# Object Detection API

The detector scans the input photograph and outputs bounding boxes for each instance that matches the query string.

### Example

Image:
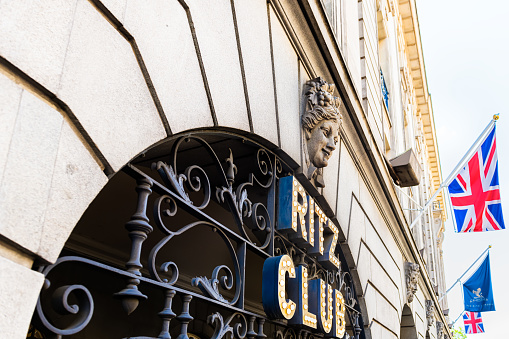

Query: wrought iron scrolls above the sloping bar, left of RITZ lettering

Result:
[143,135,283,258]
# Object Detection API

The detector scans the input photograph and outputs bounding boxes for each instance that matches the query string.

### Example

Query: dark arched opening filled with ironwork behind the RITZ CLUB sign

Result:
[30,132,365,339]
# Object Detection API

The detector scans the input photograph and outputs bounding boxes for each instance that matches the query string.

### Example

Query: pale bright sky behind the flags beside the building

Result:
[417,0,509,339]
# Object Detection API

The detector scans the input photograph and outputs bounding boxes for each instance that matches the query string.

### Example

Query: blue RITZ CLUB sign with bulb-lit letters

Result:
[262,176,345,338]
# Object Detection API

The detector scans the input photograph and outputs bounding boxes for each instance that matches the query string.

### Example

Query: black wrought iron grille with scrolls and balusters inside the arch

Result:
[29,135,363,339]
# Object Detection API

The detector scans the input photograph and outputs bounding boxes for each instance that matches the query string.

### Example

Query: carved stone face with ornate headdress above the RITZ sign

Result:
[301,77,341,187]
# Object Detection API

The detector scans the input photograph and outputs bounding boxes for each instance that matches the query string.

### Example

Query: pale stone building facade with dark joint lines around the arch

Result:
[0,0,451,338]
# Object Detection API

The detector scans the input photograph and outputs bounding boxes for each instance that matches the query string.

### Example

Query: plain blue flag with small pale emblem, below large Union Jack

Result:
[463,252,495,312]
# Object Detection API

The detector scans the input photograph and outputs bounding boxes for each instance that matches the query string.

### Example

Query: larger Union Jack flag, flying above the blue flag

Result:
[448,125,505,233]
